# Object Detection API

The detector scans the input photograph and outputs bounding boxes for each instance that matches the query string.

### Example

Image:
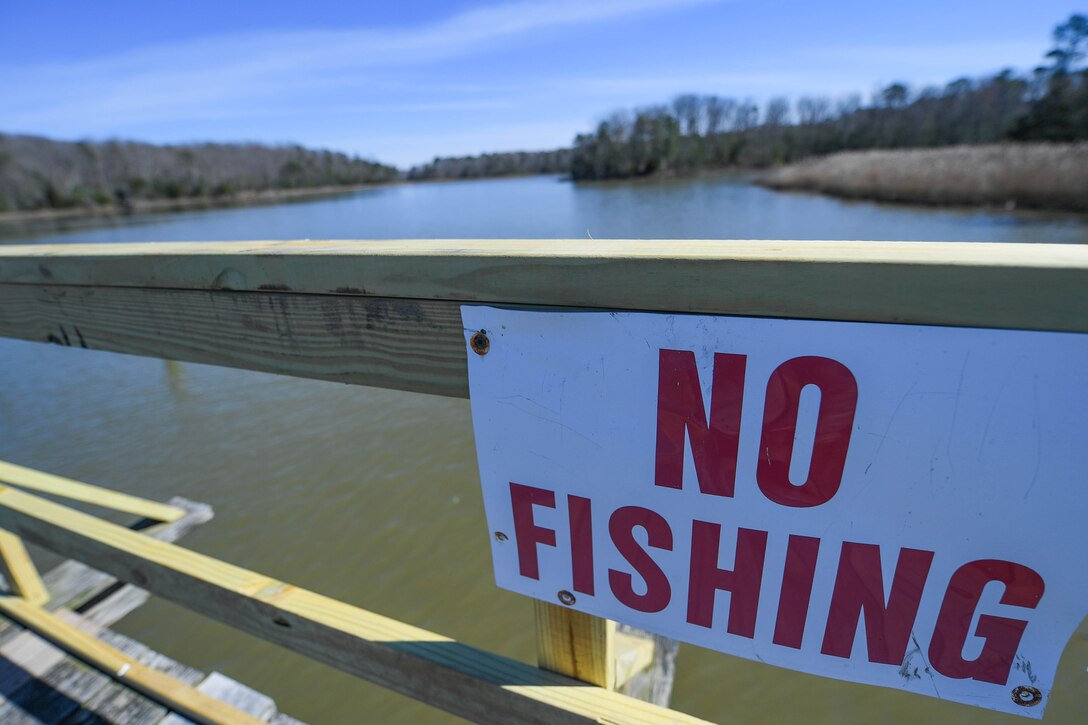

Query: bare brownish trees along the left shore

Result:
[0,135,399,211]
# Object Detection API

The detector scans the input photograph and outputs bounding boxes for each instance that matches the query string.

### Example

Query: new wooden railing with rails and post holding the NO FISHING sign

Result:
[0,241,1088,723]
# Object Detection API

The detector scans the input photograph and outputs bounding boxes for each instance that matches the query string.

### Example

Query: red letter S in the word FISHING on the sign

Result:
[608,506,672,612]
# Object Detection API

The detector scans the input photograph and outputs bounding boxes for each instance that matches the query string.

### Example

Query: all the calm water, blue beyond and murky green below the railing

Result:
[0,177,1088,725]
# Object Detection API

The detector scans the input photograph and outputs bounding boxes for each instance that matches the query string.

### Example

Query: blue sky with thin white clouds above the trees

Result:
[0,0,1085,167]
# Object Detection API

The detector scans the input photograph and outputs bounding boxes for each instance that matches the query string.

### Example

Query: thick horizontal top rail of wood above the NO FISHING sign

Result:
[0,239,1088,397]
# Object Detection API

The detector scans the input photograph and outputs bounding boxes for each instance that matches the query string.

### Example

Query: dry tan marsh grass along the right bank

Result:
[759,143,1088,211]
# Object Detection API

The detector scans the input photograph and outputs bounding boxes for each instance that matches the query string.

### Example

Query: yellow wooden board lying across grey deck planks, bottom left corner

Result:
[0,597,261,725]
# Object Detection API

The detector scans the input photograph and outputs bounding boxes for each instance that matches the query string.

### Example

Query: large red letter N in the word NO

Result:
[654,349,745,496]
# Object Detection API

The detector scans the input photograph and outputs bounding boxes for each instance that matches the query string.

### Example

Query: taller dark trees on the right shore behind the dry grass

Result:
[570,15,1088,180]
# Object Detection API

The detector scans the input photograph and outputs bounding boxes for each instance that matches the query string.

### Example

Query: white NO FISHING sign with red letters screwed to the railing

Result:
[461,306,1088,717]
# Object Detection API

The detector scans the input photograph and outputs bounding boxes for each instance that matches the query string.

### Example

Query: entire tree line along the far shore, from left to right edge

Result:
[0,15,1088,211]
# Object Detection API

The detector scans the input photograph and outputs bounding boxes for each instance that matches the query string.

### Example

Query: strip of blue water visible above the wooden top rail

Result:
[6,176,1088,243]
